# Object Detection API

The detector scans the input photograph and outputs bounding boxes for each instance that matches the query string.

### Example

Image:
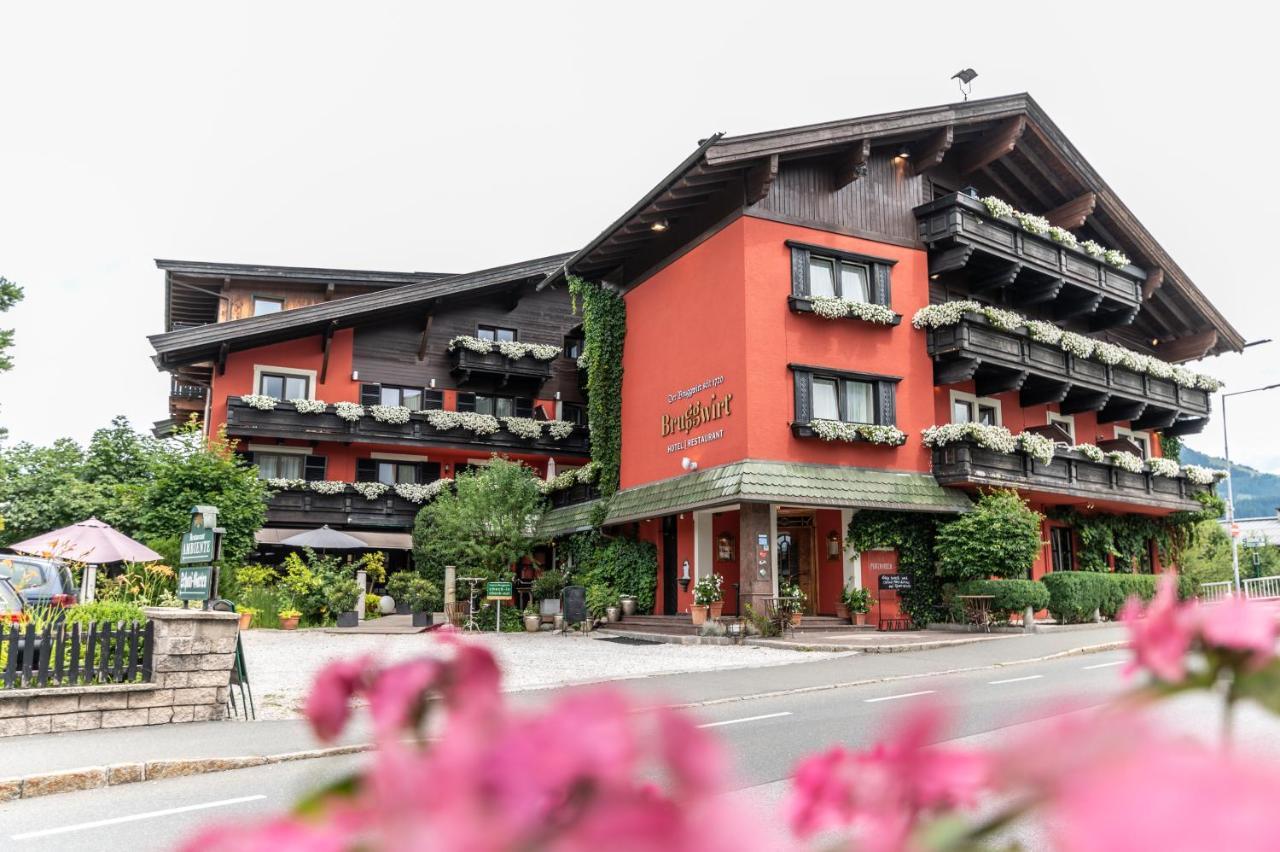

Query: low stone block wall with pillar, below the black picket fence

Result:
[0,609,239,737]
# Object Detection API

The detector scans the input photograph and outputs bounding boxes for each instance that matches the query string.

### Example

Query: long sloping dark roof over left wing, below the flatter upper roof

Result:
[147,253,568,370]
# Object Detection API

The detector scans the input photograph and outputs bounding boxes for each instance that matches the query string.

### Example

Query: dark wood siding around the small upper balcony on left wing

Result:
[352,278,582,402]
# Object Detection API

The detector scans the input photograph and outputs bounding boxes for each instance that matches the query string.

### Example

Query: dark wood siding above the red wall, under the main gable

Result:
[748,152,928,246]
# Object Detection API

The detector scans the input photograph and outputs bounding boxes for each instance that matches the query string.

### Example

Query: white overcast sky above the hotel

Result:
[0,0,1280,471]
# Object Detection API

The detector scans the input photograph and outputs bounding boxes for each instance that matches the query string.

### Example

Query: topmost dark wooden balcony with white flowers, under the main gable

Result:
[915,193,1147,330]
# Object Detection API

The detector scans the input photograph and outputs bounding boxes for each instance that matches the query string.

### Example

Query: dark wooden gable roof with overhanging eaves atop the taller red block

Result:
[544,93,1244,359]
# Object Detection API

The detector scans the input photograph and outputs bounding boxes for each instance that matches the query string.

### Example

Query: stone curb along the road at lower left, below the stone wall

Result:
[0,743,374,802]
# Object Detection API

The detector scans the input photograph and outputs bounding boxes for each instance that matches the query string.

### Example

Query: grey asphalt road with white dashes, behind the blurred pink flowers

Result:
[0,652,1126,852]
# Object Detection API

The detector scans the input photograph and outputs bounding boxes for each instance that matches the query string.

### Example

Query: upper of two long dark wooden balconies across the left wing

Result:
[227,397,590,459]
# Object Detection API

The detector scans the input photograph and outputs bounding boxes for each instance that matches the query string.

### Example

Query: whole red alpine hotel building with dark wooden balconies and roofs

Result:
[151,95,1243,619]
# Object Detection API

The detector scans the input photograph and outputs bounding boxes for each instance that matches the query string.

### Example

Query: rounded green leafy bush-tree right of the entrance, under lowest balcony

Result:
[933,490,1044,581]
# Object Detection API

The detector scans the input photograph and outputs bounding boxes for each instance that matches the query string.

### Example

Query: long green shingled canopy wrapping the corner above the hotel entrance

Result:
[605,461,973,523]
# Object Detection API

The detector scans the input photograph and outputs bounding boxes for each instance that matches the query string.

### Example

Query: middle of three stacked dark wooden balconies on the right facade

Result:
[928,313,1210,435]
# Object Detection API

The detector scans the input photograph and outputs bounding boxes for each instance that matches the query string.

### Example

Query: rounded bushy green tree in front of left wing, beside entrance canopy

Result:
[413,455,545,583]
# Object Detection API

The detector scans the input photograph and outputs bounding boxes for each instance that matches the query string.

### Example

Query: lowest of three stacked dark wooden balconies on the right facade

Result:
[933,441,1212,512]
